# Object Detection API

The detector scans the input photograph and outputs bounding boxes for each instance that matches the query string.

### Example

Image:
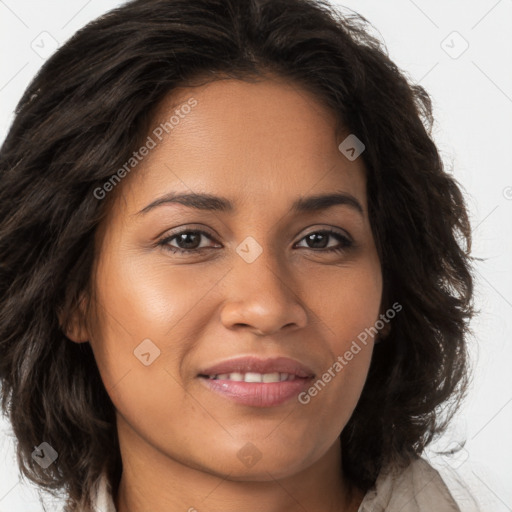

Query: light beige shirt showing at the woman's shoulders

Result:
[93,459,460,512]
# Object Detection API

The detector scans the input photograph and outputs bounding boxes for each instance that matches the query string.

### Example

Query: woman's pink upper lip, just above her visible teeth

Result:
[199,356,315,378]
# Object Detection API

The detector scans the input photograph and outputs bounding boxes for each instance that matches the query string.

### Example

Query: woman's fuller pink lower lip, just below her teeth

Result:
[199,377,311,407]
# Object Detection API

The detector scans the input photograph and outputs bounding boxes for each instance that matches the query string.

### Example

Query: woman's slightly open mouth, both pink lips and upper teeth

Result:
[197,357,315,407]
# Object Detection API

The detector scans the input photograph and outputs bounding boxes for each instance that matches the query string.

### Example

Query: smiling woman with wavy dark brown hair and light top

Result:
[0,0,473,512]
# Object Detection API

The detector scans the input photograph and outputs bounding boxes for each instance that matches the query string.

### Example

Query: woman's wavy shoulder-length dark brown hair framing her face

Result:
[0,0,474,510]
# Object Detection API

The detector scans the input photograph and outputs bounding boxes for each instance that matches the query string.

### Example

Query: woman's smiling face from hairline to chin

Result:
[82,79,382,480]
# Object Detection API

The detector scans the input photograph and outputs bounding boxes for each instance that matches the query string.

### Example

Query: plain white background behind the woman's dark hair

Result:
[0,0,512,512]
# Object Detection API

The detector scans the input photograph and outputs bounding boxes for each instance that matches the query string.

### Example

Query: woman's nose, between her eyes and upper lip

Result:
[221,250,308,335]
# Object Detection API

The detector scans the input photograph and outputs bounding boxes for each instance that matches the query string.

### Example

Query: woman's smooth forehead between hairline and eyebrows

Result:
[114,78,366,214]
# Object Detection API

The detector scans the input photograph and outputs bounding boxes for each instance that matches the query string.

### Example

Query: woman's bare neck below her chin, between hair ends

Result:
[114,416,363,512]
